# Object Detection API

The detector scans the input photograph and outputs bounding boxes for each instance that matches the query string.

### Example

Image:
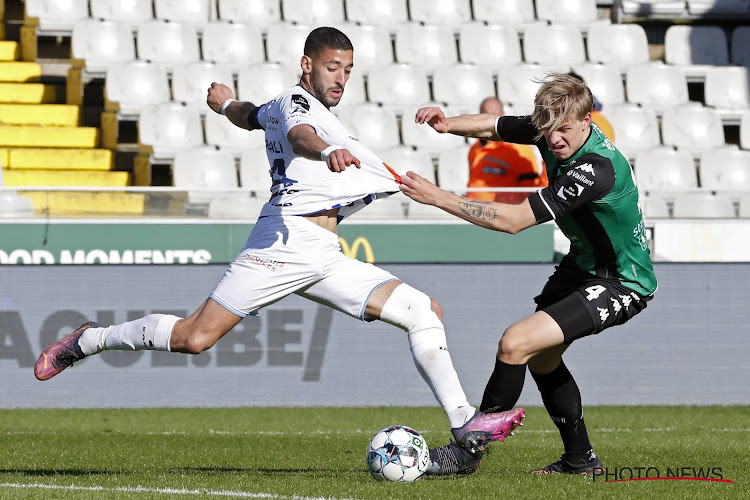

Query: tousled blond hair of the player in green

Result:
[531,73,594,139]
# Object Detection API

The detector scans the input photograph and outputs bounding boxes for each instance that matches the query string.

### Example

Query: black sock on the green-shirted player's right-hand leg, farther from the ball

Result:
[531,360,592,462]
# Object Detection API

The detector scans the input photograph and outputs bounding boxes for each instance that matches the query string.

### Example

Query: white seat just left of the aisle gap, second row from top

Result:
[586,24,649,74]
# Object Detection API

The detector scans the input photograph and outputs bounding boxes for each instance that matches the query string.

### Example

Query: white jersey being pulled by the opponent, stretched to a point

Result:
[257,85,399,221]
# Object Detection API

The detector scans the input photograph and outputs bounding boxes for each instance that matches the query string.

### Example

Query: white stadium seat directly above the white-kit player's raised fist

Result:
[203,22,265,73]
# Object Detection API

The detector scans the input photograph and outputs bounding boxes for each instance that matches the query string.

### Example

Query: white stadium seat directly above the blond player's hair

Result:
[523,24,586,65]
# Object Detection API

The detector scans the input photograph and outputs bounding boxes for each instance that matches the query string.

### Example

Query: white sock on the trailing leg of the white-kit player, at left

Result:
[78,314,180,356]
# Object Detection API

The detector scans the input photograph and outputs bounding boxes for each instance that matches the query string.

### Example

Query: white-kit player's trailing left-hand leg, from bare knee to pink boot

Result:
[34,299,242,380]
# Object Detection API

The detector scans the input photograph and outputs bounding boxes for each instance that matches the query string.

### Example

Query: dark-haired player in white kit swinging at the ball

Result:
[34,28,525,462]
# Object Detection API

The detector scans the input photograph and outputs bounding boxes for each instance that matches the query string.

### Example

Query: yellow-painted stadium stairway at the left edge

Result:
[0,25,145,216]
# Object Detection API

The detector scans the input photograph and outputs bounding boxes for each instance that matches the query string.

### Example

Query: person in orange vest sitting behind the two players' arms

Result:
[466,97,547,203]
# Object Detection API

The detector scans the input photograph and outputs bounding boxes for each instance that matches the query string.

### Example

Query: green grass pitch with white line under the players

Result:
[0,407,750,500]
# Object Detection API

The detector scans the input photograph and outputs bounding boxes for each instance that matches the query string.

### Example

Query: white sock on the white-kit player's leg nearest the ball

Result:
[409,327,476,428]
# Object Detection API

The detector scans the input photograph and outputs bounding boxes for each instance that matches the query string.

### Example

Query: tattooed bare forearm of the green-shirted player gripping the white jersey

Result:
[400,172,537,234]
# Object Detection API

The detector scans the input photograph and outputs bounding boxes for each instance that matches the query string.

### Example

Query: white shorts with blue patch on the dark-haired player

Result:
[211,215,397,320]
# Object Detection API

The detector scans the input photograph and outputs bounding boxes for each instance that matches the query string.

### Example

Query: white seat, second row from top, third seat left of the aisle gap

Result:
[458,23,521,66]
